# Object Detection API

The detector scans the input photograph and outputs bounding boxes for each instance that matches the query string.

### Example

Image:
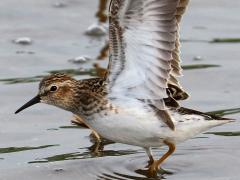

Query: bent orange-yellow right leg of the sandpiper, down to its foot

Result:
[148,141,176,177]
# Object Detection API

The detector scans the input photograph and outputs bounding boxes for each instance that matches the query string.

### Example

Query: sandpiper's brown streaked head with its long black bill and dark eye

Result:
[15,74,78,114]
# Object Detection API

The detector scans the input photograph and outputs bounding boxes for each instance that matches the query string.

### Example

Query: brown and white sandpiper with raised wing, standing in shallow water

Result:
[16,0,232,175]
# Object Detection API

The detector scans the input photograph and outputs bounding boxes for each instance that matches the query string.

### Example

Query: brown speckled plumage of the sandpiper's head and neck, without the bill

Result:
[39,74,108,115]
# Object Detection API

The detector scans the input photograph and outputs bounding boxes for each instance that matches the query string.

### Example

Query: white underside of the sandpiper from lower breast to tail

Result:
[82,100,231,147]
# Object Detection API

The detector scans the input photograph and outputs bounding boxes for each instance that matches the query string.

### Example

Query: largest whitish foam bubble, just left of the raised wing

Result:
[86,23,107,36]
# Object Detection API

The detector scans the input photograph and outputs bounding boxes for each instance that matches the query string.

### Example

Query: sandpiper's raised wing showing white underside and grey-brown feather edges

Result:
[108,0,188,109]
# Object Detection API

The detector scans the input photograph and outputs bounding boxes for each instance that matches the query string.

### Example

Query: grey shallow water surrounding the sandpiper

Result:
[0,0,240,180]
